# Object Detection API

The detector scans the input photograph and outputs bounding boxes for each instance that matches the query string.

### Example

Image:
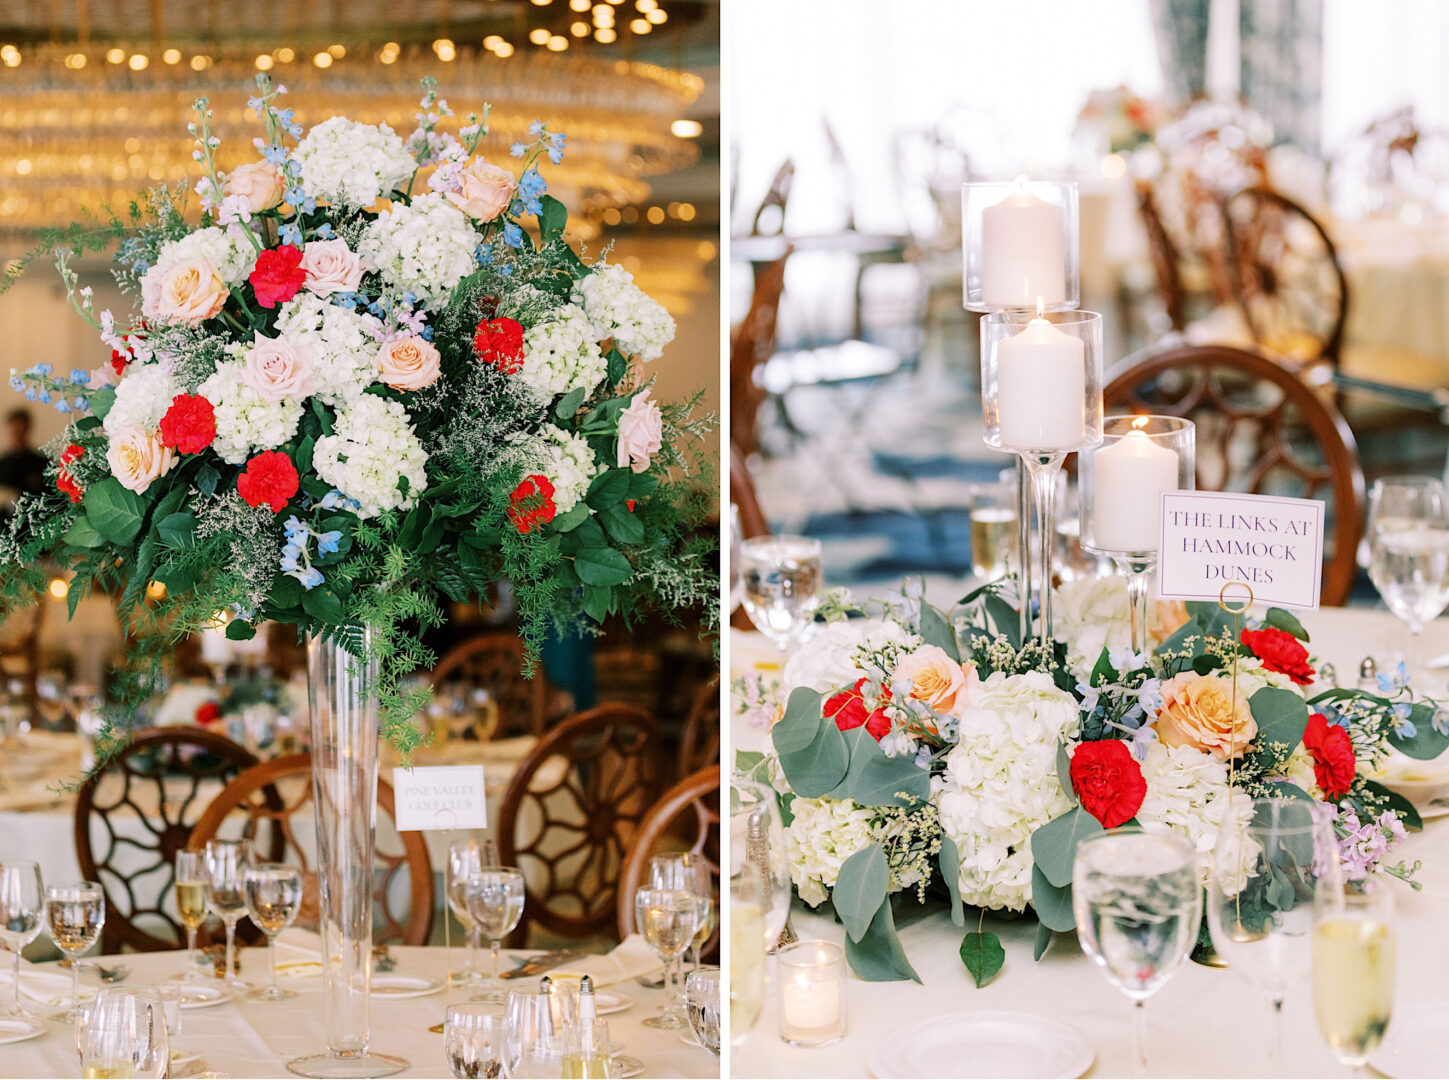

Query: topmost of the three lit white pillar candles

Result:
[981,180,1066,307]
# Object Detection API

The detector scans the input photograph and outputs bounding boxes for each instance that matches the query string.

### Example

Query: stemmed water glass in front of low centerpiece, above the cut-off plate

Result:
[1072,829,1203,1076]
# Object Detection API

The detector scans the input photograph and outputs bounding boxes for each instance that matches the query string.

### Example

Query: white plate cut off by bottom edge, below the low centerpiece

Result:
[867,1009,1095,1080]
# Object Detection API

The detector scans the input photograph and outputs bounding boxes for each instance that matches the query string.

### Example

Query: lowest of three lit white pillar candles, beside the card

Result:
[1093,431,1178,552]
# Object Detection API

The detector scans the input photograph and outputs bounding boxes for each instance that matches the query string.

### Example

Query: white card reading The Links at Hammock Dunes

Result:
[1158,491,1323,607]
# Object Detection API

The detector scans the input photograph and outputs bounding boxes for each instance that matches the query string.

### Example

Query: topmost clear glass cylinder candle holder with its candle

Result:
[961,177,1081,312]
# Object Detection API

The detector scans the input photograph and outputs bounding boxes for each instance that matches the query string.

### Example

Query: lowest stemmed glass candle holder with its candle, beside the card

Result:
[1078,416,1197,652]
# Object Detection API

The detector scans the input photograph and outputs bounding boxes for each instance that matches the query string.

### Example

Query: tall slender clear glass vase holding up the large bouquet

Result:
[287,631,407,1077]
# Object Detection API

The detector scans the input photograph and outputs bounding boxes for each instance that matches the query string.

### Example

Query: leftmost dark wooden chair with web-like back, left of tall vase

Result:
[75,728,256,952]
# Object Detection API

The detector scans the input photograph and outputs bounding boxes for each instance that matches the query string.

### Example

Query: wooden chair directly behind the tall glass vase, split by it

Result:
[187,754,433,945]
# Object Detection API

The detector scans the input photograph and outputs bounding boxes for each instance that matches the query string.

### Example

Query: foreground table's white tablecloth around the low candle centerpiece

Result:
[730,609,1449,1077]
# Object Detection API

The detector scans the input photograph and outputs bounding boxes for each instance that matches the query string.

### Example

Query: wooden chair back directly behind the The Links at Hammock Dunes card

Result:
[1103,345,1364,606]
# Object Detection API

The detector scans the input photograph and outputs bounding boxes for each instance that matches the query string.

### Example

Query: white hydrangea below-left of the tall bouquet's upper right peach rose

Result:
[358,191,478,307]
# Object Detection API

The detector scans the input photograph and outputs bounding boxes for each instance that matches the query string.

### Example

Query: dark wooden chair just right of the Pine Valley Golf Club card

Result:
[497,705,658,945]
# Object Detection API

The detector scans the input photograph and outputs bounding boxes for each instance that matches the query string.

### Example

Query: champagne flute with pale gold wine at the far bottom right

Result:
[1313,881,1395,1076]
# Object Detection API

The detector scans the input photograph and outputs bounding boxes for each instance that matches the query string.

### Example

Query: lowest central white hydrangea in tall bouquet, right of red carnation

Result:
[312,394,427,518]
